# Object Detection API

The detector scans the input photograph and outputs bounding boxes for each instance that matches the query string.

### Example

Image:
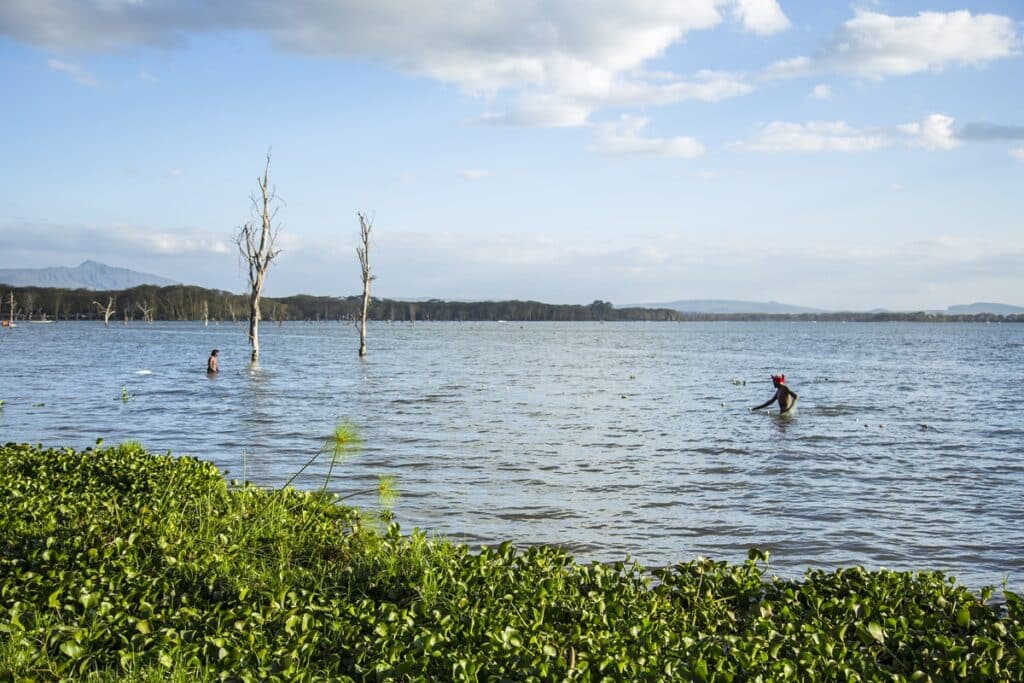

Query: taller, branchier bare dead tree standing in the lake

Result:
[234,152,281,362]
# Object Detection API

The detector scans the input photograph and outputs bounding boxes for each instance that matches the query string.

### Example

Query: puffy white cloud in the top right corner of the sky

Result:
[766,10,1021,79]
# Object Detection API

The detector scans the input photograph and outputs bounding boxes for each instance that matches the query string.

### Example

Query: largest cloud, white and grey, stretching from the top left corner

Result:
[0,0,788,126]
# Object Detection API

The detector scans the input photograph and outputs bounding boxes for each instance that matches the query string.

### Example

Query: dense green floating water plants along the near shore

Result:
[0,444,1024,682]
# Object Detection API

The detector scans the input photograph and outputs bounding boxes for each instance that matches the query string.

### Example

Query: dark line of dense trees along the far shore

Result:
[0,285,1024,323]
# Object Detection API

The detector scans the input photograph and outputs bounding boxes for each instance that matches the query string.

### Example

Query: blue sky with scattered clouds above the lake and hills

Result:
[0,0,1024,309]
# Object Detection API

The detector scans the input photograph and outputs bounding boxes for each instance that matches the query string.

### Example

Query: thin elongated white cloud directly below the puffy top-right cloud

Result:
[732,114,961,153]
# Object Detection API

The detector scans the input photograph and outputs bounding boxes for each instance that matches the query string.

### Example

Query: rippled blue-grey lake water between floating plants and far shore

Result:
[0,322,1024,590]
